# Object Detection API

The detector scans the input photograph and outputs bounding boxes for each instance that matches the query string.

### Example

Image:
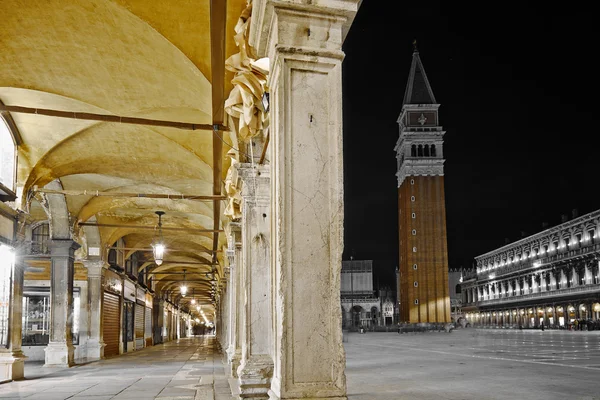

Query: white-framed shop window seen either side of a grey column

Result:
[22,287,80,346]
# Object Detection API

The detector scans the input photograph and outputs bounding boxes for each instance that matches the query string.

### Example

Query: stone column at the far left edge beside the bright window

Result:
[0,257,27,383]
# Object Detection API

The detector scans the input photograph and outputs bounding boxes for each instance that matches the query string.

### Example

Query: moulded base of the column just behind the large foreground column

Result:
[237,355,273,400]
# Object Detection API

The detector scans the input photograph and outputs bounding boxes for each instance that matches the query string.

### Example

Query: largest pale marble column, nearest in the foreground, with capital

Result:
[250,0,360,400]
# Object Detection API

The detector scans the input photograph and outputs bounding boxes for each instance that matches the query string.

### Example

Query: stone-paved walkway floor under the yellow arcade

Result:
[0,336,232,400]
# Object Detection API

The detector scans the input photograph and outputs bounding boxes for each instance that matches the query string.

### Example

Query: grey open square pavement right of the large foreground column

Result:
[344,328,600,400]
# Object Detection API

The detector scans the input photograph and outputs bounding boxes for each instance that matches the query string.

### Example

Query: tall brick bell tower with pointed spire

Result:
[395,42,450,323]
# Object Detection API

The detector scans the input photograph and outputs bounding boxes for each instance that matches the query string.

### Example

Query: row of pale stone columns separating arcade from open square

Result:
[216,0,359,399]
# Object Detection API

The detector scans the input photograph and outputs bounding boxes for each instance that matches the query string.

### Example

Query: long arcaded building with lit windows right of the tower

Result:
[462,210,600,328]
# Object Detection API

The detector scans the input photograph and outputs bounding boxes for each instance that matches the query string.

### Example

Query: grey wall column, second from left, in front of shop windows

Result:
[44,239,80,367]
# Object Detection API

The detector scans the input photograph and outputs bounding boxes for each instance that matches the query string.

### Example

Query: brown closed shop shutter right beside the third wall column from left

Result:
[102,270,123,357]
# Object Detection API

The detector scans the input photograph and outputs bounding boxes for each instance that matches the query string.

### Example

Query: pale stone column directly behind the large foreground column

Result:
[237,164,273,399]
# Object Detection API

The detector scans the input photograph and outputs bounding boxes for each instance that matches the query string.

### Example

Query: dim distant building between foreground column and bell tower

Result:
[341,260,398,328]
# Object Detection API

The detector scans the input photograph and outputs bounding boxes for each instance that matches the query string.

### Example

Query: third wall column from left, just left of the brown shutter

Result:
[83,259,107,360]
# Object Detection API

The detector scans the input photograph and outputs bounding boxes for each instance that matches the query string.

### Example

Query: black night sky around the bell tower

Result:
[343,0,600,286]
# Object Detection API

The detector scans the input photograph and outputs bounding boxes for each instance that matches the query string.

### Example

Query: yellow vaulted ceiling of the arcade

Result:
[0,0,246,318]
